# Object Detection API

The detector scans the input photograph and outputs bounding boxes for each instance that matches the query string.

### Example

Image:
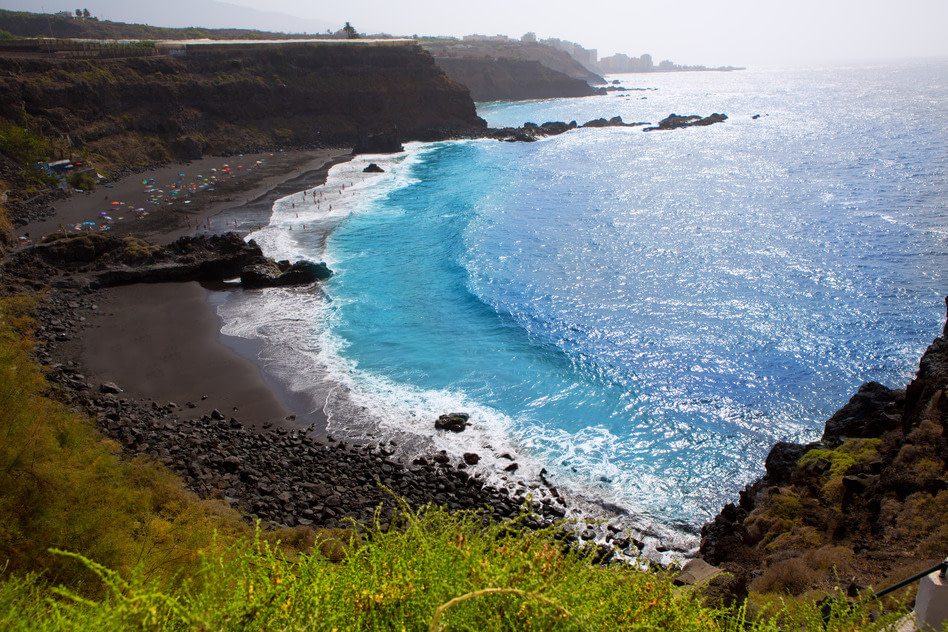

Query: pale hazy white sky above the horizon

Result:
[0,0,948,66]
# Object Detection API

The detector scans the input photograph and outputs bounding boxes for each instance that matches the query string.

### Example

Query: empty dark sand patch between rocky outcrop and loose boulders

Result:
[82,283,302,426]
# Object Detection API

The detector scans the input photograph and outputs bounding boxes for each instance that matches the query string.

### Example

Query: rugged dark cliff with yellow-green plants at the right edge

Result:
[701,302,948,594]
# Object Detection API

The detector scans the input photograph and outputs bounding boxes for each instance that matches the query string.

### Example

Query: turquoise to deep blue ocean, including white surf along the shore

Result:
[218,60,948,548]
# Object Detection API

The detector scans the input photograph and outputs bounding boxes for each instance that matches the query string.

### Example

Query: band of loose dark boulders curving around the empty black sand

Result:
[35,287,645,561]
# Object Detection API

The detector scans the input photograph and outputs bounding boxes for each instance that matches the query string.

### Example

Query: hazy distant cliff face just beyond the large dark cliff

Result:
[437,57,600,101]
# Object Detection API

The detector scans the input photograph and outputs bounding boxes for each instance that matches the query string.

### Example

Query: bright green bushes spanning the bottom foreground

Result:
[0,509,904,632]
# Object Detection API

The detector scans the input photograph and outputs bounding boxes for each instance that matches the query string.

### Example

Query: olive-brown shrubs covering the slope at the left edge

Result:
[0,298,247,585]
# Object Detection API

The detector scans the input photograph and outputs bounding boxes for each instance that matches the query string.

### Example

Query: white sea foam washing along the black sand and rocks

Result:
[218,143,695,561]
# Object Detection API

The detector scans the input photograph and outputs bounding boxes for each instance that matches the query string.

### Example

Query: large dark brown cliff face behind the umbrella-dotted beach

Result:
[0,43,486,167]
